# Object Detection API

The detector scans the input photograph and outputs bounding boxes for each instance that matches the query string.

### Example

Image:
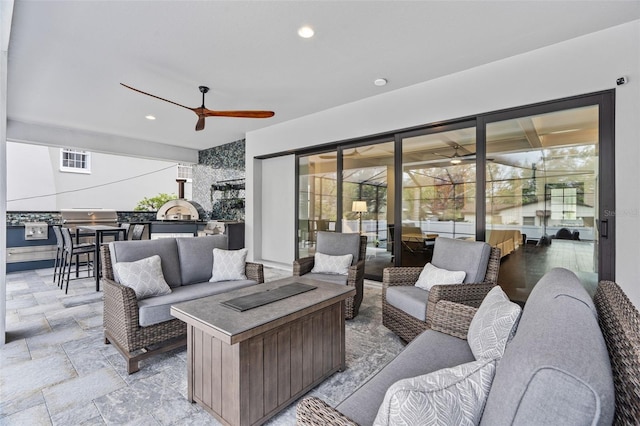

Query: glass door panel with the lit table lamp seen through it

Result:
[341,141,394,280]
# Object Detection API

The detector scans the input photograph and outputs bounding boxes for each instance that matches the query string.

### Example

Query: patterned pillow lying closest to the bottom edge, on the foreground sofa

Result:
[373,359,496,426]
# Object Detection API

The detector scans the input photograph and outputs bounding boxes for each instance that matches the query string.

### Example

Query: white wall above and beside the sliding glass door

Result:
[246,21,640,306]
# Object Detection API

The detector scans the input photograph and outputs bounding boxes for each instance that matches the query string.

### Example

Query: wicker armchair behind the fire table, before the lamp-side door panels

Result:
[293,231,367,319]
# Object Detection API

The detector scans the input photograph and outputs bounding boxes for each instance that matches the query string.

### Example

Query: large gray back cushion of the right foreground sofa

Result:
[481,268,614,426]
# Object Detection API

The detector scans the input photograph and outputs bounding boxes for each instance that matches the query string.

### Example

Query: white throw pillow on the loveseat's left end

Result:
[113,254,171,300]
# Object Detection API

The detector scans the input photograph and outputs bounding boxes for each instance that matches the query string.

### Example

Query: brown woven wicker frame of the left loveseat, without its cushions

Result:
[100,244,264,374]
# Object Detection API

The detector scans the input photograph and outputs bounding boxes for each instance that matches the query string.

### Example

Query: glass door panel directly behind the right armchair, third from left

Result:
[396,127,476,266]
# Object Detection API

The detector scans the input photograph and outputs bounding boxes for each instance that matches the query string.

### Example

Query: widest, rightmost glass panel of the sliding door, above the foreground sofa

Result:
[486,105,599,301]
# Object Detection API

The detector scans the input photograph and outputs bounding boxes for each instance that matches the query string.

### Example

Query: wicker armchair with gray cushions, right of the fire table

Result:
[382,238,500,342]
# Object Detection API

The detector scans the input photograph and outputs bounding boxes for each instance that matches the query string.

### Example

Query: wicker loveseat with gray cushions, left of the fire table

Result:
[101,235,264,374]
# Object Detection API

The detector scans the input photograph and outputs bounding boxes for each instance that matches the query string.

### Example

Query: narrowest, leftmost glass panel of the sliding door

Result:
[298,151,338,257]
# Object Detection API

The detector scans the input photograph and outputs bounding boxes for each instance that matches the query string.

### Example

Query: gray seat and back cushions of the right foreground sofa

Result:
[298,268,615,426]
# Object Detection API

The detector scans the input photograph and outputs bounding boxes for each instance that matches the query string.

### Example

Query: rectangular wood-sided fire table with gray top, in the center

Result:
[171,277,355,425]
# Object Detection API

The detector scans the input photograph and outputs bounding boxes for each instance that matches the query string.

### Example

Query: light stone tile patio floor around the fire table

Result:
[0,268,403,426]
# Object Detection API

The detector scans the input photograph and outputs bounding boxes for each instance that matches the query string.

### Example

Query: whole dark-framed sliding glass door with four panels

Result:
[297,91,615,301]
